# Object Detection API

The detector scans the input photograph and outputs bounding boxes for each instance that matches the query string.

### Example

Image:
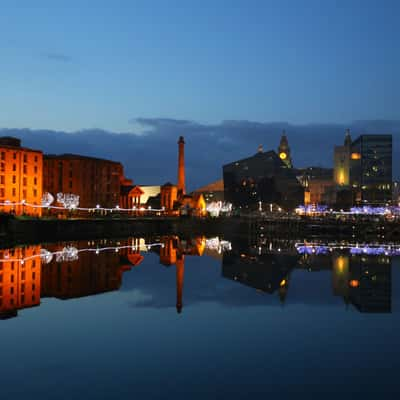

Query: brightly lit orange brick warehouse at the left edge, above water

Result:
[0,137,43,216]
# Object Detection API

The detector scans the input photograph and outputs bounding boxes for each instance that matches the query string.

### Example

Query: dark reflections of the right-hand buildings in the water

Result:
[222,241,392,313]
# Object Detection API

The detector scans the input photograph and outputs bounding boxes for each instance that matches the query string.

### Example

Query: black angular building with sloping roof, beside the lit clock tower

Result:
[223,150,304,209]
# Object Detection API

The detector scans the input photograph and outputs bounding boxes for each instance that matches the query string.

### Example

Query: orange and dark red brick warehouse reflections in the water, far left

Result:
[0,239,143,319]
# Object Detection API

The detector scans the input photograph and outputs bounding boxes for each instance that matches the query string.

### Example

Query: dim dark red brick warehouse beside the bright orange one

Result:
[43,154,127,208]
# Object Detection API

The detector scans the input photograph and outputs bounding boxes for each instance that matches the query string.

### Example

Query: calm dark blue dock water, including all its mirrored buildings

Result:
[0,237,400,399]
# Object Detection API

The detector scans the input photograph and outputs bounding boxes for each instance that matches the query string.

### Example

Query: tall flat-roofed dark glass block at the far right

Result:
[350,135,392,205]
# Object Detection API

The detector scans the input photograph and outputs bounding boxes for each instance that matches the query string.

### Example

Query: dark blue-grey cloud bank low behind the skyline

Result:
[0,118,400,189]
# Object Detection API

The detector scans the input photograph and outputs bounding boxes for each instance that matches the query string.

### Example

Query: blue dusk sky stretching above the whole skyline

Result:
[0,0,400,188]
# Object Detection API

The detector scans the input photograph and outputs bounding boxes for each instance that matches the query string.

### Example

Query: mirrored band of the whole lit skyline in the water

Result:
[0,236,399,319]
